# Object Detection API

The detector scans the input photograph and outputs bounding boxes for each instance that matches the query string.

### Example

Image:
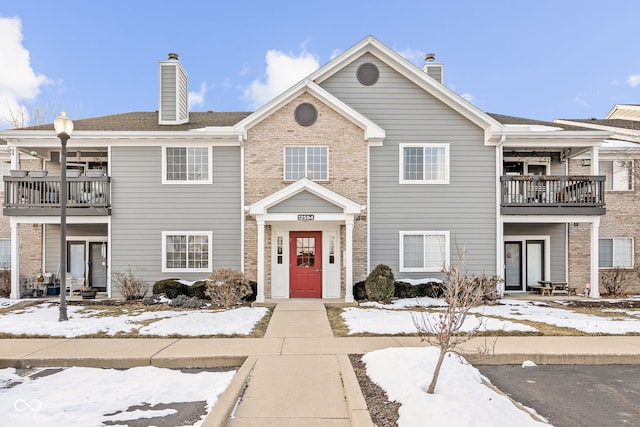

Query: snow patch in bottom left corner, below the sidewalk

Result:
[0,366,235,427]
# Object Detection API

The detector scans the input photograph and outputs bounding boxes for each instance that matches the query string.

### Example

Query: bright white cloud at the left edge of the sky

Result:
[0,16,49,127]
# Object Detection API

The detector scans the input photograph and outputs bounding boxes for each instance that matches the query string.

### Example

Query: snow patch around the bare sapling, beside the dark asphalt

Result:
[362,347,548,427]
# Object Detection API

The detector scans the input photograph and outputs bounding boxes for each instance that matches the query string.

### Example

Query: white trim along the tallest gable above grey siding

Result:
[309,36,503,144]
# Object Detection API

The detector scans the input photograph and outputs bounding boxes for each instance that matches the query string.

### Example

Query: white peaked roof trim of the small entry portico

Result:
[247,178,363,215]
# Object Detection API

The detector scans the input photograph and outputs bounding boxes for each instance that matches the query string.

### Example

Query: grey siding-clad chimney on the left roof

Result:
[158,53,189,125]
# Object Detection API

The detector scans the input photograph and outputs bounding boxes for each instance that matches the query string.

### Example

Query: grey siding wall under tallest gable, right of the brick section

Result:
[322,54,496,278]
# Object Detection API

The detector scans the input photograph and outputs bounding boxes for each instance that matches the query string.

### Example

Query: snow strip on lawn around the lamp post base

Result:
[0,303,268,338]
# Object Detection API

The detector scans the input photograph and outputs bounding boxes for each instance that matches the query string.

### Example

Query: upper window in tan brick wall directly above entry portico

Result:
[284,146,329,181]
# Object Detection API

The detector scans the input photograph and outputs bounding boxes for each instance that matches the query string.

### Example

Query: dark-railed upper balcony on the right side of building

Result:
[500,175,606,215]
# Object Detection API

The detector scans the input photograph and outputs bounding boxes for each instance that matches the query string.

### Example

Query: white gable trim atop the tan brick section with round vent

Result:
[234,79,386,140]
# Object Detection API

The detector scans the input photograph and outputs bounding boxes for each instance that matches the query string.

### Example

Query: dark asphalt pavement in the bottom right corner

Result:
[476,365,640,427]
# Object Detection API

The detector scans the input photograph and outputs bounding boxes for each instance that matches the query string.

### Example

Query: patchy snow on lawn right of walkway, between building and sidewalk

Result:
[342,298,640,335]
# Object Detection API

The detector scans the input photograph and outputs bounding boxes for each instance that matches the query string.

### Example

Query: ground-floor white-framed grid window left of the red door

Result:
[162,231,213,272]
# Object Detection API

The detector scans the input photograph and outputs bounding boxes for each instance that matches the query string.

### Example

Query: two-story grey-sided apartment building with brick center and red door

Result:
[0,37,611,301]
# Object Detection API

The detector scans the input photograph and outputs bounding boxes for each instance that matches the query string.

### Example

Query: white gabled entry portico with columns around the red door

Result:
[246,178,366,302]
